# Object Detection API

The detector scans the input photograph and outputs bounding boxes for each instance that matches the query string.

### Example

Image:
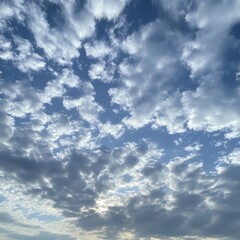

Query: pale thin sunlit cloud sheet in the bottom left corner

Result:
[0,178,78,240]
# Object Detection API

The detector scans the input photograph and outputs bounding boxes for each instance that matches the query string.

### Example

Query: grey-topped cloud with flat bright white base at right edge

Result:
[182,76,240,137]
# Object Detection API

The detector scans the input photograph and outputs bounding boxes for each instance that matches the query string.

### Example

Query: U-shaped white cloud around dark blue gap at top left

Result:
[28,2,95,65]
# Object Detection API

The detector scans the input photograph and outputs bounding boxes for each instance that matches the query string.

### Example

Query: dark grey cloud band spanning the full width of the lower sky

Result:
[0,140,240,239]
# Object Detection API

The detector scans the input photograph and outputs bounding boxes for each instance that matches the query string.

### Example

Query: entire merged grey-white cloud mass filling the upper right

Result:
[109,1,239,138]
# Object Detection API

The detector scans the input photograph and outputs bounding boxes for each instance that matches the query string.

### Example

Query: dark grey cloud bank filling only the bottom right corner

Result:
[74,149,239,239]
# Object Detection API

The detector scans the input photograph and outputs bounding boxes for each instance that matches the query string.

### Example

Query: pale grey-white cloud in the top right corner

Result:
[183,0,240,76]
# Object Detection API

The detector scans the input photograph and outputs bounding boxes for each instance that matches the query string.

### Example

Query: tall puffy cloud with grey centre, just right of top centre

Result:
[109,21,184,133]
